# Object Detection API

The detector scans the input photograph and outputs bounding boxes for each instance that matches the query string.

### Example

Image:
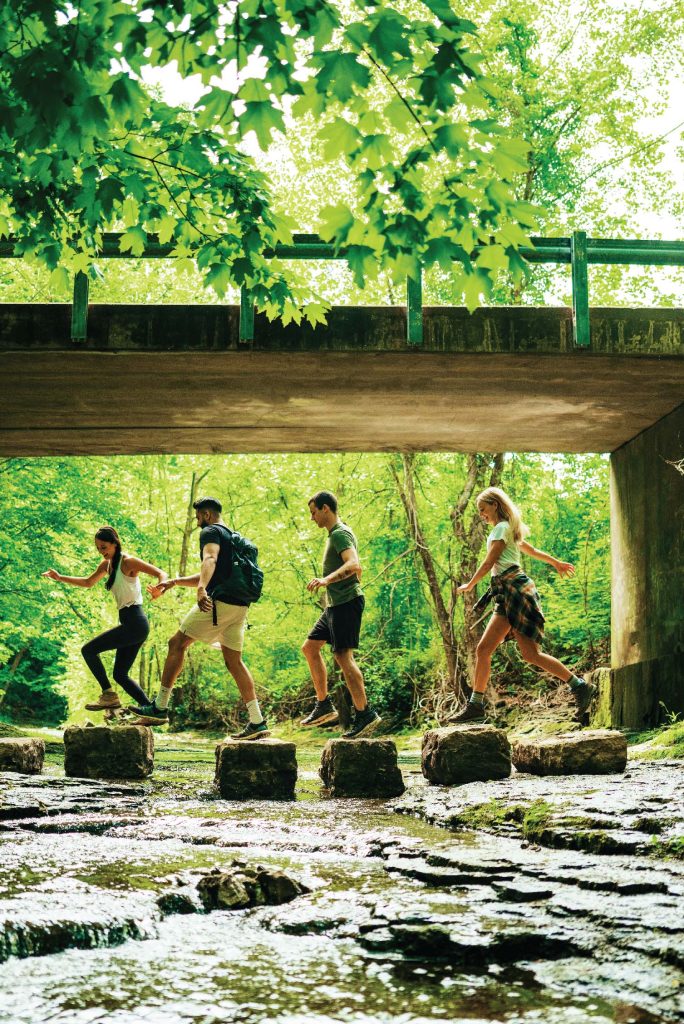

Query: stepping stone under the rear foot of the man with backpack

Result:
[214,737,297,800]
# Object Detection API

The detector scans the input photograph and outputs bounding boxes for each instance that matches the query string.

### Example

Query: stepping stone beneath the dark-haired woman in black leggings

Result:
[65,725,155,778]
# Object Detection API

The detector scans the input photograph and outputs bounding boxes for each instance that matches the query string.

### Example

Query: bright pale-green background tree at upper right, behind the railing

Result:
[479,0,684,304]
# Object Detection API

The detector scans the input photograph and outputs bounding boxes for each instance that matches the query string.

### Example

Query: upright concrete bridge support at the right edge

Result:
[606,406,684,729]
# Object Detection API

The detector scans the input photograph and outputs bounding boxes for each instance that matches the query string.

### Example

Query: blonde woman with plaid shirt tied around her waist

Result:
[453,487,596,723]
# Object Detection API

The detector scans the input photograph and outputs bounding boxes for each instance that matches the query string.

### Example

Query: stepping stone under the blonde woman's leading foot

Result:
[421,725,511,785]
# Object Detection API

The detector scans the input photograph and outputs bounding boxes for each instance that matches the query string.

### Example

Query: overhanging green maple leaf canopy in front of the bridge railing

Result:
[0,0,535,322]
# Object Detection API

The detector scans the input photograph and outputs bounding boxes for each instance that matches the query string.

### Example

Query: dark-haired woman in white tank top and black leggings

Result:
[43,526,167,711]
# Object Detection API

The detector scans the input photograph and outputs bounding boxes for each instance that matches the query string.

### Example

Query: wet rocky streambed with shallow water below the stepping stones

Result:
[0,737,684,1024]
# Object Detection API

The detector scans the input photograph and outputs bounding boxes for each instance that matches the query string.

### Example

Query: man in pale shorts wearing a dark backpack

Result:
[133,498,269,739]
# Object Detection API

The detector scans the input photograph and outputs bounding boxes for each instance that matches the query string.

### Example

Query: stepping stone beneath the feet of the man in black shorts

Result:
[318,739,405,799]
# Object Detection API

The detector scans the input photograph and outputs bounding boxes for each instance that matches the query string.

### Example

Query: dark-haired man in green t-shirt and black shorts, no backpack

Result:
[301,490,380,739]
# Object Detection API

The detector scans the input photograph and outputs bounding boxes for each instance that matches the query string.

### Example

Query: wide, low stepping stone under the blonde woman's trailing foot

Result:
[513,729,627,775]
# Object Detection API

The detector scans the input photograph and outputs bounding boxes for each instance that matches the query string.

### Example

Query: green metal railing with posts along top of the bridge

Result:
[0,231,684,348]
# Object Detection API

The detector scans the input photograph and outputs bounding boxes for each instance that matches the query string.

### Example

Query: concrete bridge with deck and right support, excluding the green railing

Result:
[0,304,684,728]
